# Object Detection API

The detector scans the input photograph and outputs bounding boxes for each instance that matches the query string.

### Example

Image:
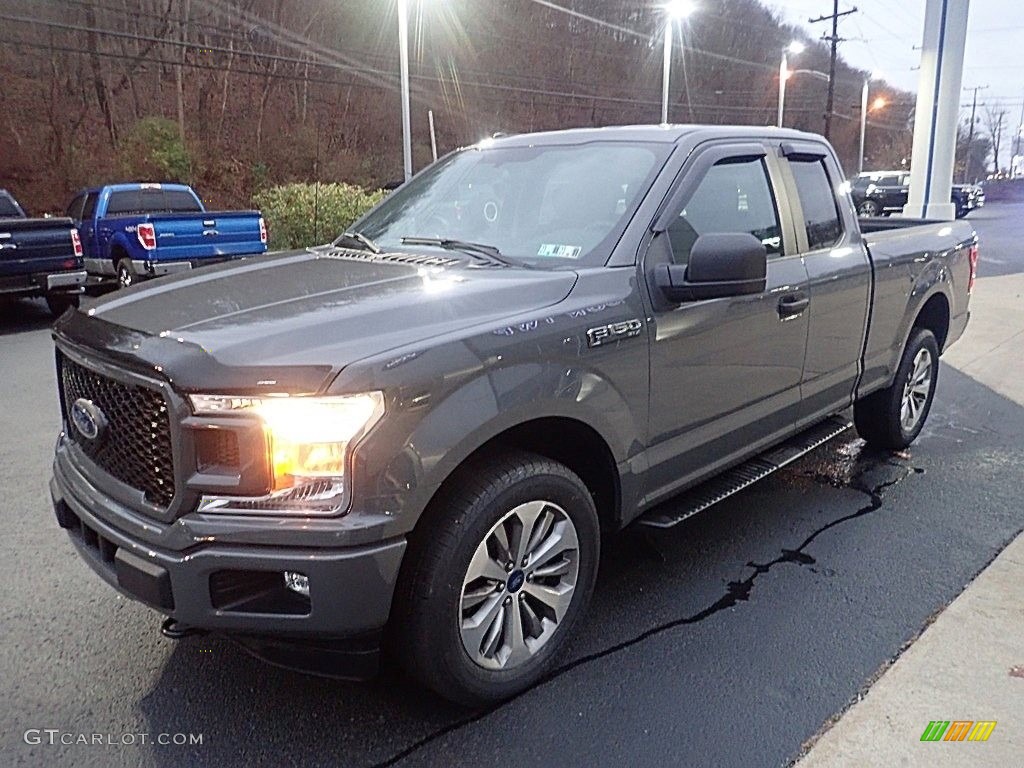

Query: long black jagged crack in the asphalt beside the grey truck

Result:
[370,460,925,768]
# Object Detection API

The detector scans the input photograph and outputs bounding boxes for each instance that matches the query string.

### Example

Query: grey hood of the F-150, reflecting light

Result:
[89,249,577,369]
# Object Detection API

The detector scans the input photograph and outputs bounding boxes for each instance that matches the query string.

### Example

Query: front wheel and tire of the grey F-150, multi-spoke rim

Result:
[389,453,600,707]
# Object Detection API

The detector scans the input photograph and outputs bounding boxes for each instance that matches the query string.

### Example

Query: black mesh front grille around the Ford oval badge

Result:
[58,355,174,507]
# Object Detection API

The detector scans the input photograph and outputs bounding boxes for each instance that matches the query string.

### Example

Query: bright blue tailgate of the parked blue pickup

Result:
[148,211,264,261]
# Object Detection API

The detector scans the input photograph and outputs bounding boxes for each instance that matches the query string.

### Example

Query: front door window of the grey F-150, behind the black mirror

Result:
[668,158,782,264]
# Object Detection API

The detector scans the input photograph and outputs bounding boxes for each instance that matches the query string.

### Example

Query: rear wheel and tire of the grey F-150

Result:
[853,328,939,451]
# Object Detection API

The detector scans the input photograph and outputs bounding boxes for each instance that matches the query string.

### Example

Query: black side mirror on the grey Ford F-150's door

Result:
[654,233,768,304]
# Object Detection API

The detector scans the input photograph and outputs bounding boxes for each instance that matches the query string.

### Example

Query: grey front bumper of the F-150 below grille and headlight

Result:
[50,444,406,642]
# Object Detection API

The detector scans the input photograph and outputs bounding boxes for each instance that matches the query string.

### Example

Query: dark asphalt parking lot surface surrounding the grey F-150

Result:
[0,204,1024,766]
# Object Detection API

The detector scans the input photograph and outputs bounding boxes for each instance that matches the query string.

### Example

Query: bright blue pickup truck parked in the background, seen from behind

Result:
[68,183,266,288]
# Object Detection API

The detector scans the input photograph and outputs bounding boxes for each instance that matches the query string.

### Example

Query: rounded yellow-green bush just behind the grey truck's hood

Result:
[253,183,385,250]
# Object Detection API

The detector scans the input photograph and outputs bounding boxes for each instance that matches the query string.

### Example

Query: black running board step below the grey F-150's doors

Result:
[636,416,853,528]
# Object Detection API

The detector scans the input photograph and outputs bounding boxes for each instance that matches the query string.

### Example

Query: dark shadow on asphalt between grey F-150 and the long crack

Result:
[139,434,913,768]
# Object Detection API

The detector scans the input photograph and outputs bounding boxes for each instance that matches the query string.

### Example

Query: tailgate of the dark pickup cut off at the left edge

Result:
[0,218,82,276]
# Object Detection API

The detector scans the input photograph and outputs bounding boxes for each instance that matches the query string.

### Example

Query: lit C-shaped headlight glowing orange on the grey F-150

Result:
[188,392,384,514]
